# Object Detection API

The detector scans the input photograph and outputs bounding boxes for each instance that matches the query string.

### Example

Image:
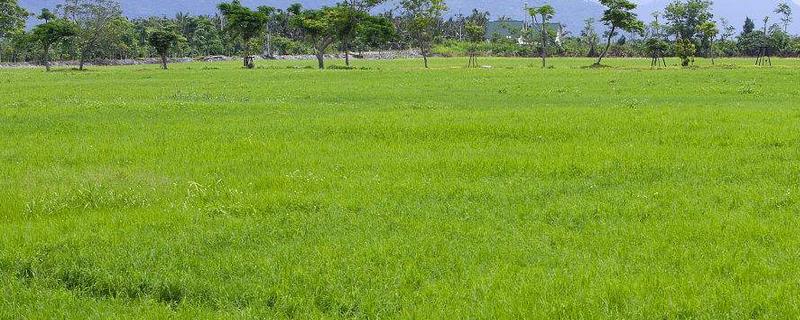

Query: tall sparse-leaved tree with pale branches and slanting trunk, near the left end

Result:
[59,0,124,70]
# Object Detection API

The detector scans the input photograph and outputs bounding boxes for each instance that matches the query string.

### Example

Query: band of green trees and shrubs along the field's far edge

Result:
[0,0,800,68]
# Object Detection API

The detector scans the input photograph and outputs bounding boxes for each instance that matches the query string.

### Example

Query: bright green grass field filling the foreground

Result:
[0,58,800,319]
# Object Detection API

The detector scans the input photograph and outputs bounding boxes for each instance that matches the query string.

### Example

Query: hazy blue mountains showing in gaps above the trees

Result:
[20,0,800,33]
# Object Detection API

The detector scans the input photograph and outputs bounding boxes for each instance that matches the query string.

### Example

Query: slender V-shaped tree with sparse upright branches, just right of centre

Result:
[400,0,447,68]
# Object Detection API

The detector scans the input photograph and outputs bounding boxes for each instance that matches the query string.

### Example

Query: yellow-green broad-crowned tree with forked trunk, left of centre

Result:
[292,6,349,69]
